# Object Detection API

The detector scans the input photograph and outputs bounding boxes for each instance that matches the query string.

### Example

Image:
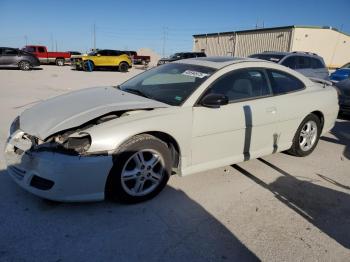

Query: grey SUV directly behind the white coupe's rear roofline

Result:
[250,51,329,80]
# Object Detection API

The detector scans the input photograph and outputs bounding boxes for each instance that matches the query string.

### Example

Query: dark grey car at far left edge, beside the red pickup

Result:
[0,47,40,70]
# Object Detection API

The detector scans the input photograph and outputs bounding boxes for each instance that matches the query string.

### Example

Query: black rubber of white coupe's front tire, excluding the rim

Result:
[106,136,172,203]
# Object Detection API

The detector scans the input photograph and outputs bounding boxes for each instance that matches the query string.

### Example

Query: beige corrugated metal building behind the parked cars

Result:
[193,25,350,68]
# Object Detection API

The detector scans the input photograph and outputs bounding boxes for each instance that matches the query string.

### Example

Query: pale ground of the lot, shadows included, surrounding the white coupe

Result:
[0,66,350,262]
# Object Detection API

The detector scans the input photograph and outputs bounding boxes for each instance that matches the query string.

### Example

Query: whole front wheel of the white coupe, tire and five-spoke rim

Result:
[106,134,172,203]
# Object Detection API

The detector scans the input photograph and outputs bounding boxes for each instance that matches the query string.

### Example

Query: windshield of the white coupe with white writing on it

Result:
[119,63,215,106]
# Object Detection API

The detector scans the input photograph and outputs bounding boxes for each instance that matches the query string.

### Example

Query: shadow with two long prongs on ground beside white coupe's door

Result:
[232,158,350,249]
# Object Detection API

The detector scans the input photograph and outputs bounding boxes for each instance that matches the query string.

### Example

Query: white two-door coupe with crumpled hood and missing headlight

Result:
[5,57,339,203]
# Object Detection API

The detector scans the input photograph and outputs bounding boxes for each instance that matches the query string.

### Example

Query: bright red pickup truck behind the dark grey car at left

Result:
[22,45,71,66]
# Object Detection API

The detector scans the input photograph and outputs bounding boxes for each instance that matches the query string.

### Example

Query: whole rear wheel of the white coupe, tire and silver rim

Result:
[288,114,322,157]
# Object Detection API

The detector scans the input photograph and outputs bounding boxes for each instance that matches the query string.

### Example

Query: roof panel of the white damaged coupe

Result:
[173,56,272,69]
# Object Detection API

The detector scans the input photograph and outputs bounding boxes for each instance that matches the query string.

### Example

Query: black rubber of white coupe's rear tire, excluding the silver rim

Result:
[291,114,321,157]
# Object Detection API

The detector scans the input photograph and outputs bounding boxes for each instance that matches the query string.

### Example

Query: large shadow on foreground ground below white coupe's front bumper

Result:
[0,170,259,262]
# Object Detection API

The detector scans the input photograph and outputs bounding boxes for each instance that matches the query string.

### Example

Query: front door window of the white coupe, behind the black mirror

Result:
[207,68,271,102]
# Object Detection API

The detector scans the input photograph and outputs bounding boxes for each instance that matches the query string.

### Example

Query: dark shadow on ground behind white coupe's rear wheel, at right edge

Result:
[320,116,350,159]
